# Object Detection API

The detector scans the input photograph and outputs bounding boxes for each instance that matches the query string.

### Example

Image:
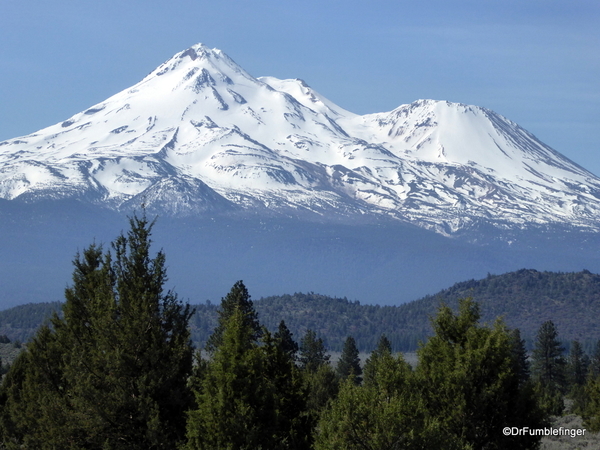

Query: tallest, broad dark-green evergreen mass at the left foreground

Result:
[2,215,193,449]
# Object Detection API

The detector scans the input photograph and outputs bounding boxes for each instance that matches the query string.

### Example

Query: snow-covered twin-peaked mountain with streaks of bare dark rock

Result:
[0,44,600,234]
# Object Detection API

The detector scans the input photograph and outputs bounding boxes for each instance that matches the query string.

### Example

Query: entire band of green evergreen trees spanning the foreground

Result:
[0,215,600,450]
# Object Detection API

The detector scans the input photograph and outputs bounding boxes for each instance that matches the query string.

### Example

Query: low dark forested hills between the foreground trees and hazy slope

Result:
[0,269,600,353]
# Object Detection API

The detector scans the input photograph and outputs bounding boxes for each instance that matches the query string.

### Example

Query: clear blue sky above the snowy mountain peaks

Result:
[0,0,600,175]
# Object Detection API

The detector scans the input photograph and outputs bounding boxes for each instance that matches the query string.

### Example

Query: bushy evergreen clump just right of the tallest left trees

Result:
[187,299,311,450]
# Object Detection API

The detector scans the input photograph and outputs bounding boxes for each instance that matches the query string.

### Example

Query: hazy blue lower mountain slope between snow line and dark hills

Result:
[0,201,600,308]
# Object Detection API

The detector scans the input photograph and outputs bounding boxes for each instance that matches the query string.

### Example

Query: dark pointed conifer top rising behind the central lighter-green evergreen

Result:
[206,280,262,353]
